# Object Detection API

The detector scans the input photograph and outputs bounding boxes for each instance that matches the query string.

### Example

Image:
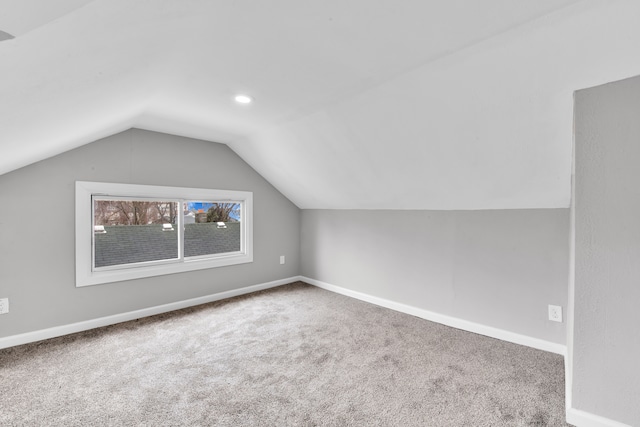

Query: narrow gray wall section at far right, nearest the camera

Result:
[572,77,640,426]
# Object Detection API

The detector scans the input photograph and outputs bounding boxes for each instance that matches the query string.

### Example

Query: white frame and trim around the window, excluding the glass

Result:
[76,181,253,287]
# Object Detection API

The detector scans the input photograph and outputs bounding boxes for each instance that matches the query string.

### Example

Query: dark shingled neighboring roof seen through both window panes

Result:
[95,222,240,267]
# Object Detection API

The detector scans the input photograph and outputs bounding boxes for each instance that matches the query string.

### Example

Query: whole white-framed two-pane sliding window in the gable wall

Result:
[76,181,253,286]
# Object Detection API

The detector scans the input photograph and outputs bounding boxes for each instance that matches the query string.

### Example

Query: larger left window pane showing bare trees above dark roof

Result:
[93,198,179,267]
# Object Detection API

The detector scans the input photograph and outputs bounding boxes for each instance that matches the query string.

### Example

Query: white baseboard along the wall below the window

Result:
[0,276,300,349]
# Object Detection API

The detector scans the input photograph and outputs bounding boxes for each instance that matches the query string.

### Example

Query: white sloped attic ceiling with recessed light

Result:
[0,0,640,209]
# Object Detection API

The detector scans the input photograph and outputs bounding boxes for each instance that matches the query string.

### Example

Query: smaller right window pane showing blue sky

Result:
[183,201,242,257]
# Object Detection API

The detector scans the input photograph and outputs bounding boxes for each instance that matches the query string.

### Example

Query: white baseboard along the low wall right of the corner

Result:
[300,276,567,356]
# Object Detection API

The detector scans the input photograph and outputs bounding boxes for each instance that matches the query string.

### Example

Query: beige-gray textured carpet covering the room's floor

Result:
[0,283,566,426]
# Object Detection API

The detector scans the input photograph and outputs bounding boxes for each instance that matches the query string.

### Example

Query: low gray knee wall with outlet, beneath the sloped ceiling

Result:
[301,209,569,344]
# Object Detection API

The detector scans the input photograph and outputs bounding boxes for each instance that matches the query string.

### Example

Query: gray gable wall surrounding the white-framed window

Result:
[0,129,300,337]
